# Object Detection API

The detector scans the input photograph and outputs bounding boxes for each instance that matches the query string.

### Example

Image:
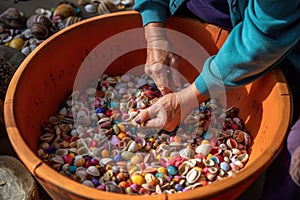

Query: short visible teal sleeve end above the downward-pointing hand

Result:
[133,0,169,26]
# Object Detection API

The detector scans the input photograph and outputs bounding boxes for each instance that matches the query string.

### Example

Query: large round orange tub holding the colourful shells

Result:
[4,11,291,200]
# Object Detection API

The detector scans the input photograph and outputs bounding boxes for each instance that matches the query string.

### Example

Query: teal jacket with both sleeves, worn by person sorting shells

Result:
[134,0,300,95]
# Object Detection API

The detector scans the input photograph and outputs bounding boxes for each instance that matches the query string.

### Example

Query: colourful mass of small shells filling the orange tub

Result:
[37,74,251,195]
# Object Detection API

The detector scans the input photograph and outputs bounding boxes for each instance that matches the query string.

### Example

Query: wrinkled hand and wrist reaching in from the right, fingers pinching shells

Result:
[135,84,207,131]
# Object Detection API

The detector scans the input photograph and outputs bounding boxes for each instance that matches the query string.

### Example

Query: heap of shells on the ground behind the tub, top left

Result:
[0,0,134,56]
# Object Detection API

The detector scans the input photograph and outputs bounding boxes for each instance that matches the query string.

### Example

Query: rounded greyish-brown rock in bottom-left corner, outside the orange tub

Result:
[0,155,39,200]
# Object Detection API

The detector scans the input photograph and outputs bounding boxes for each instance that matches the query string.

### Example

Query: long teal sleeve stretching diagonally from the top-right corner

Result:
[195,0,300,95]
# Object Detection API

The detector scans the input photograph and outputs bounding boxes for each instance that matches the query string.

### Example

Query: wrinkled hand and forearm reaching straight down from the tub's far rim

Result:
[145,23,183,95]
